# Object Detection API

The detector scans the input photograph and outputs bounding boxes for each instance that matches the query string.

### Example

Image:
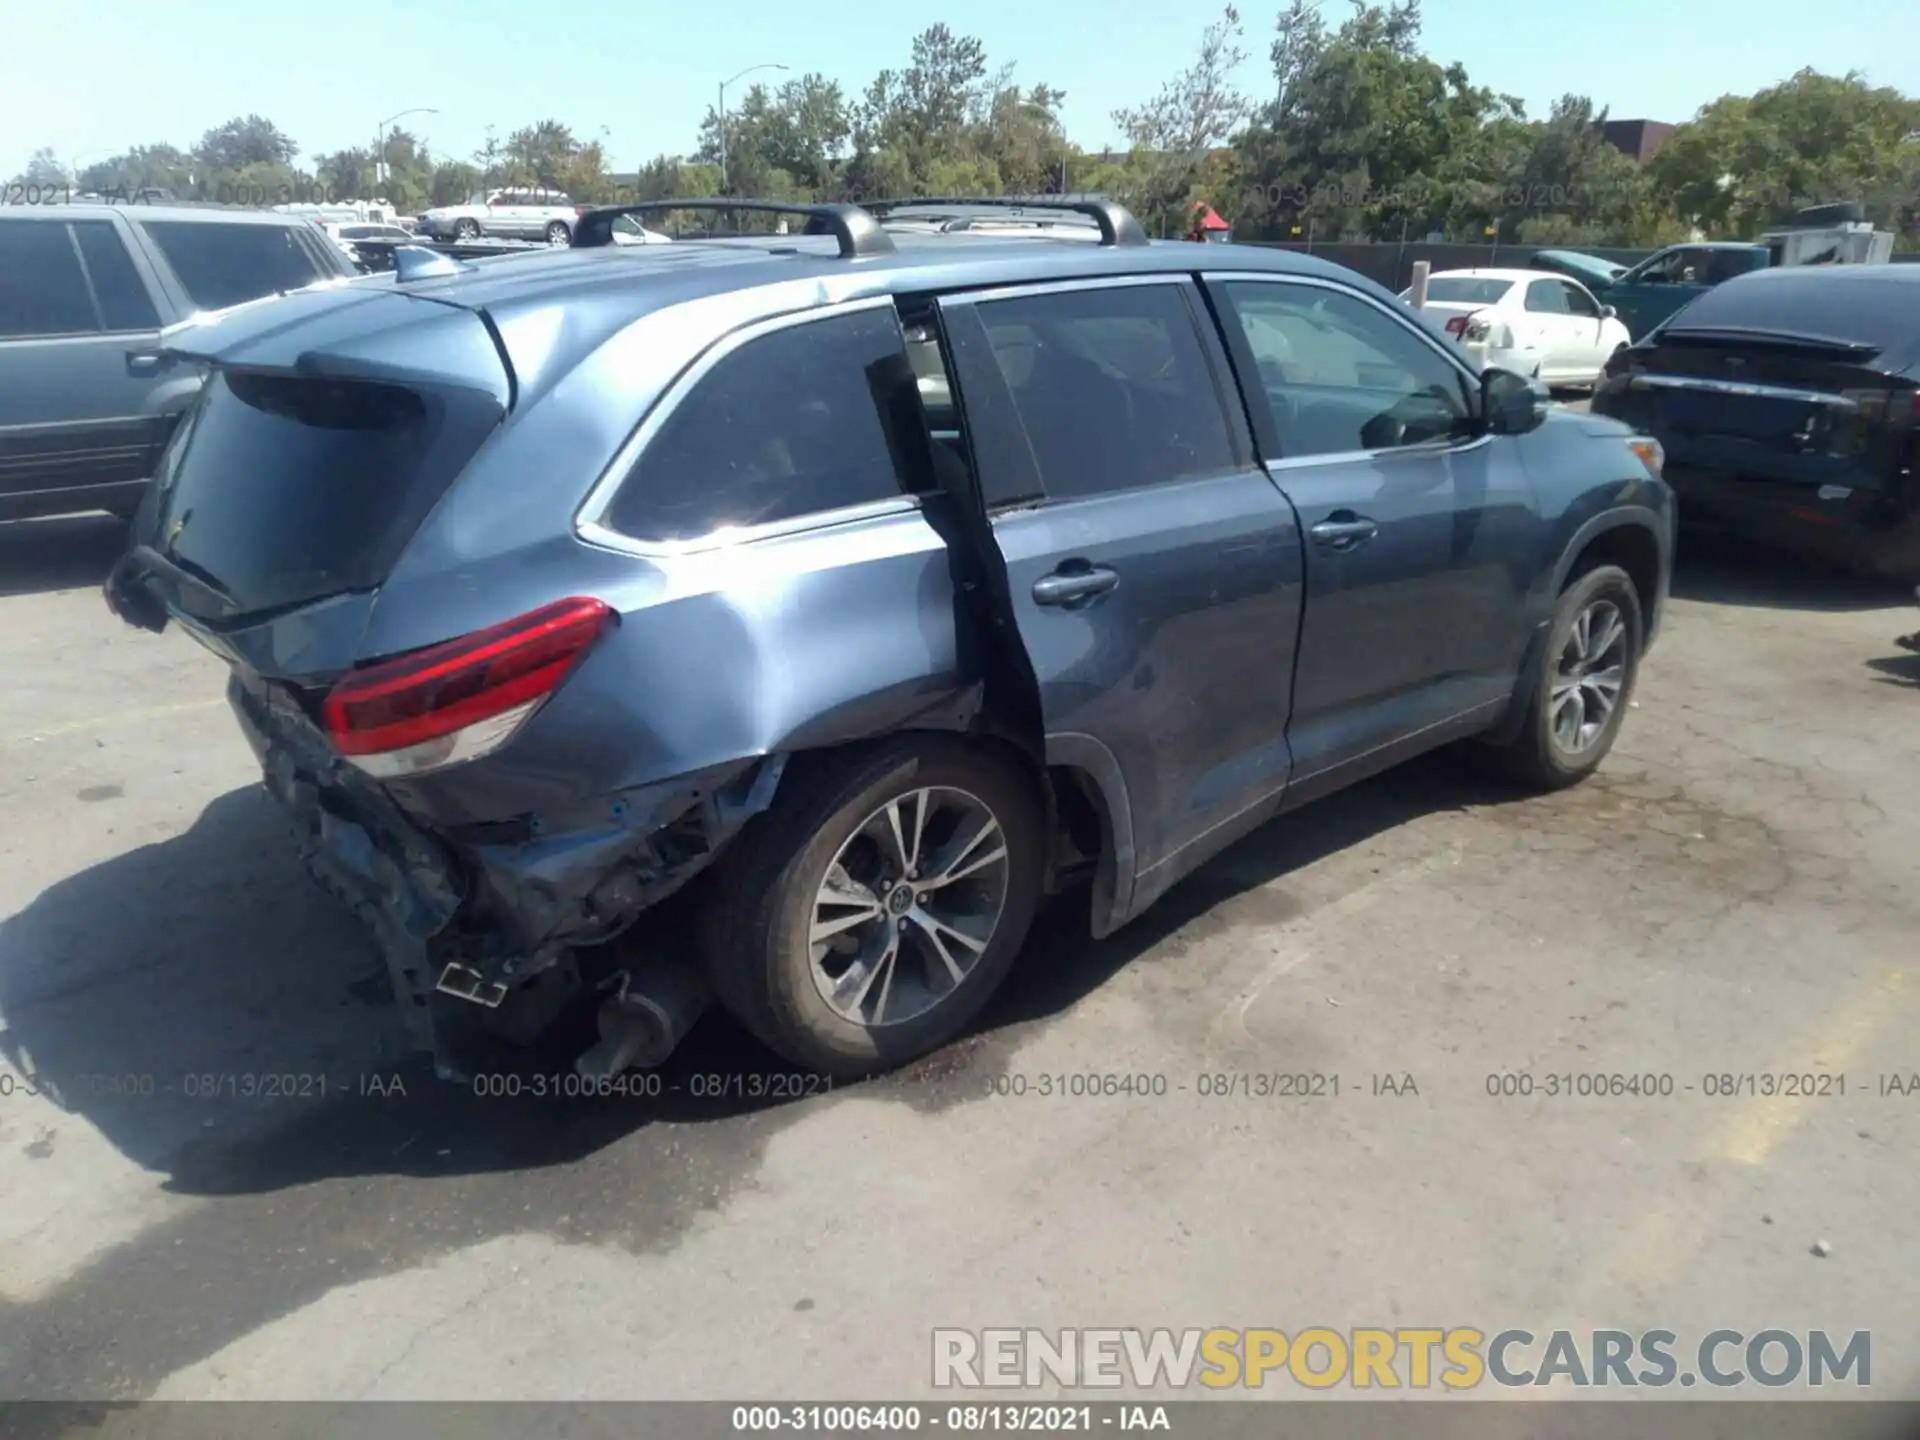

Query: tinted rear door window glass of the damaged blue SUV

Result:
[977,284,1235,499]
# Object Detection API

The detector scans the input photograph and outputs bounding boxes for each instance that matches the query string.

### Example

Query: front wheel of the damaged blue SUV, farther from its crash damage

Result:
[1484,564,1645,791]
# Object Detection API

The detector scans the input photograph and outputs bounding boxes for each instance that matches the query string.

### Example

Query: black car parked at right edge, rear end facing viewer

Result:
[1594,265,1920,584]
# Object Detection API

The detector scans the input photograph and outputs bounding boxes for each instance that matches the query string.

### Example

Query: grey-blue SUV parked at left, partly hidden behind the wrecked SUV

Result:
[0,204,355,520]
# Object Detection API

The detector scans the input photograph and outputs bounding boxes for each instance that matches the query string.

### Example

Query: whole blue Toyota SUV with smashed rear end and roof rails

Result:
[108,202,1670,1075]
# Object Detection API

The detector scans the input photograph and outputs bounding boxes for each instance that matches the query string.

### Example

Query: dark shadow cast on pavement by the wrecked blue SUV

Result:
[0,756,1528,1194]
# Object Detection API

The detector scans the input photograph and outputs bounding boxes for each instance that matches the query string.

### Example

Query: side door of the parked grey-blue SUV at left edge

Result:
[0,215,171,516]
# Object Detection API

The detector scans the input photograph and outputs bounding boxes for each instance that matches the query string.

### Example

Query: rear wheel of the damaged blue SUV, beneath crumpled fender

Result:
[703,735,1044,1077]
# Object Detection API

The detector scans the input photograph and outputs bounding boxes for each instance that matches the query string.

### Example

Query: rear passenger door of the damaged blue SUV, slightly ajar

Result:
[920,275,1302,914]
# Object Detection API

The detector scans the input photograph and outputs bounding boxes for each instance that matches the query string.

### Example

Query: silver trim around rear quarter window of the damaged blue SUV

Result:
[574,294,920,561]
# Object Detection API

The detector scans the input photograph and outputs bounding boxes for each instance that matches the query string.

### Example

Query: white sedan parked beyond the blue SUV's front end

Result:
[1400,271,1632,386]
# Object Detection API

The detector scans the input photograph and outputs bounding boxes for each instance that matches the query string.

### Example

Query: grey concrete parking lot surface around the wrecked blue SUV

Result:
[0,518,1920,1398]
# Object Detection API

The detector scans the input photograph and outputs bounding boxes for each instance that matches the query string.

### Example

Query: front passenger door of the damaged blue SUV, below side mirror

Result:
[1206,273,1542,799]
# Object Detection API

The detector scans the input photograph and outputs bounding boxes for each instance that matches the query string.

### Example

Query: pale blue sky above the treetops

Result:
[0,0,1920,177]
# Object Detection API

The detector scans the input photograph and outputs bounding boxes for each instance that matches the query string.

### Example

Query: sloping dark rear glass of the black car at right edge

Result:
[1665,267,1920,351]
